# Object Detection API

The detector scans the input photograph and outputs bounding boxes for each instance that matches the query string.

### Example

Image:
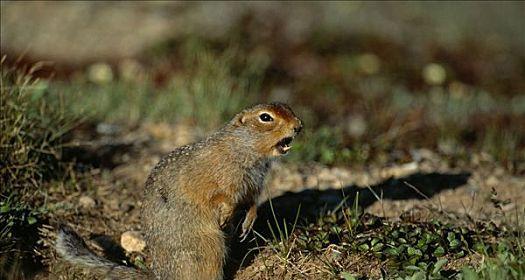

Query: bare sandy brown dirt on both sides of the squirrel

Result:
[27,124,525,279]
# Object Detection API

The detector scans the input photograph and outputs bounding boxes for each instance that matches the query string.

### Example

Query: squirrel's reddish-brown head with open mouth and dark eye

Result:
[230,103,303,157]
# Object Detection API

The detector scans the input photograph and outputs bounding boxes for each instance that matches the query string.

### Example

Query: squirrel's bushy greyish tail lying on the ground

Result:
[55,226,147,279]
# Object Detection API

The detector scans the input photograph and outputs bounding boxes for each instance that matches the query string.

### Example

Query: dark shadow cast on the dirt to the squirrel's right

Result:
[225,172,470,279]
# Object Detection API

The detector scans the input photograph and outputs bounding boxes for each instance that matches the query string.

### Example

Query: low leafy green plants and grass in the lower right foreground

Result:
[263,198,525,279]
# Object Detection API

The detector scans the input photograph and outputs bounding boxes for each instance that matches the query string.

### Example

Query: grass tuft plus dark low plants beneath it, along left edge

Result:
[0,57,76,279]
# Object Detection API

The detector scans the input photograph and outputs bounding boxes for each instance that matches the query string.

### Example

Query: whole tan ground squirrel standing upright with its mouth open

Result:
[56,103,302,280]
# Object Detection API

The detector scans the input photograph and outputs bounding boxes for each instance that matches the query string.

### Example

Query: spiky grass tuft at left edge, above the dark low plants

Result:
[0,60,74,189]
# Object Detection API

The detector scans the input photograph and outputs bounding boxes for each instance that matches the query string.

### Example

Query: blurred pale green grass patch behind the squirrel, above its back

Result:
[54,42,266,130]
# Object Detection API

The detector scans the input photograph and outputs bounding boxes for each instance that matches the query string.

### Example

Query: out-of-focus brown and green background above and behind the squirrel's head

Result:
[1,1,525,172]
